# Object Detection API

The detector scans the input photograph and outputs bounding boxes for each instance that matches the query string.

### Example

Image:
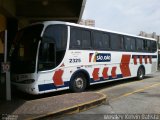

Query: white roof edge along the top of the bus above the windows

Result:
[37,21,156,41]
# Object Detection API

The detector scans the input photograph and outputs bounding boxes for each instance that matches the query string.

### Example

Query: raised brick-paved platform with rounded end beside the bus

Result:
[0,92,106,120]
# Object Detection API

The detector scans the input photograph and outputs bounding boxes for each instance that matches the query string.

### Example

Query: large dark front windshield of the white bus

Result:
[11,24,43,73]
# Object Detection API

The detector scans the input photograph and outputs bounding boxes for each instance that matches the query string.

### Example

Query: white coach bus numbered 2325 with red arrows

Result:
[10,21,158,94]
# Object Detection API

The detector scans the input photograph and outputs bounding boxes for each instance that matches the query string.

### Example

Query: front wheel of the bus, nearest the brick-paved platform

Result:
[70,74,87,92]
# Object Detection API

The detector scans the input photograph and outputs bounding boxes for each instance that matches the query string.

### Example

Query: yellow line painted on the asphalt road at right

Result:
[111,83,160,101]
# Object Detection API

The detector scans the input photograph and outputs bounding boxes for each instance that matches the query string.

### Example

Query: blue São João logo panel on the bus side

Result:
[89,52,111,62]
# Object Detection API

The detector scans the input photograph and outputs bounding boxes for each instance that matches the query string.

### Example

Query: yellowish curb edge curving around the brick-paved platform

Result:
[25,92,107,120]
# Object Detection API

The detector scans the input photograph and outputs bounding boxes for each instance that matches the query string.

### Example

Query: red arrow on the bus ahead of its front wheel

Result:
[53,69,64,86]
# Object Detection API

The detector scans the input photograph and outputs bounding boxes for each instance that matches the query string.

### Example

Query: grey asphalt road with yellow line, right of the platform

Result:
[54,72,160,120]
